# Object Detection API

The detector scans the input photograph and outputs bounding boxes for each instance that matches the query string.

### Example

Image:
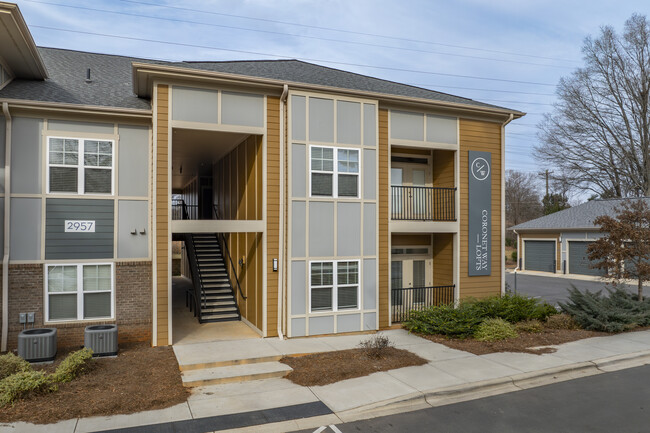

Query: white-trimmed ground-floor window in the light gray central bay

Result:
[309,260,359,312]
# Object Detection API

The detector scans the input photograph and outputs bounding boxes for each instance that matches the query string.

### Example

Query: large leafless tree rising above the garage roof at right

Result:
[535,15,650,197]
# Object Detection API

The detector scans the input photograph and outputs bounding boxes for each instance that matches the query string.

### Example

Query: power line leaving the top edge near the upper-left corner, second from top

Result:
[23,0,572,69]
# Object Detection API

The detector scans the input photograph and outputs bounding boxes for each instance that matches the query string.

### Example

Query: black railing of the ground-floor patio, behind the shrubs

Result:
[391,284,456,323]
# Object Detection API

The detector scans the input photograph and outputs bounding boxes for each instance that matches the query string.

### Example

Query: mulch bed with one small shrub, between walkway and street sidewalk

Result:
[280,347,428,386]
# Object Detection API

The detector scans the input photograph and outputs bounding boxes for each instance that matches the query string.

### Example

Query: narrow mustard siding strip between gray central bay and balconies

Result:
[377,109,390,329]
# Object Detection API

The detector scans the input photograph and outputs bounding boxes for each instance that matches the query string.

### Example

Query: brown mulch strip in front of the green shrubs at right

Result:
[417,328,610,355]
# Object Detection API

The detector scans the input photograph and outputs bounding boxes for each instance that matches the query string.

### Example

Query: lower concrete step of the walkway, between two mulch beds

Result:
[177,361,292,387]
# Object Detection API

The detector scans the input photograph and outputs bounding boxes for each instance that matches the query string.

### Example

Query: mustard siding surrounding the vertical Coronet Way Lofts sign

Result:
[459,119,503,299]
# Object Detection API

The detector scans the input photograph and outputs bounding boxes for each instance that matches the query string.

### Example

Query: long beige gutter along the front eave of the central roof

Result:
[132,62,526,119]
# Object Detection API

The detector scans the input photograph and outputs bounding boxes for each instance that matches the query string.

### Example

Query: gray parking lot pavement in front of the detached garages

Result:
[506,272,650,305]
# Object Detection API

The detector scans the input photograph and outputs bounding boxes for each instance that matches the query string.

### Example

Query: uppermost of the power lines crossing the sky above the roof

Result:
[120,0,577,63]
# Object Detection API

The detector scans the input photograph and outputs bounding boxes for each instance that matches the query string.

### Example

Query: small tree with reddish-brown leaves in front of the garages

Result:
[587,200,650,301]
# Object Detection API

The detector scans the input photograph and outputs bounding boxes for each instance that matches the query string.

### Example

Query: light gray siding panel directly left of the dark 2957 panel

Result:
[10,198,41,260]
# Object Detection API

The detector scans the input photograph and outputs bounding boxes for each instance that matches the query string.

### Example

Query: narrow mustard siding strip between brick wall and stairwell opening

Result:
[154,85,171,346]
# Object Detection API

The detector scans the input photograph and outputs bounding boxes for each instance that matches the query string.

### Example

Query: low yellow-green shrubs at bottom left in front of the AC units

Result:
[0,349,93,407]
